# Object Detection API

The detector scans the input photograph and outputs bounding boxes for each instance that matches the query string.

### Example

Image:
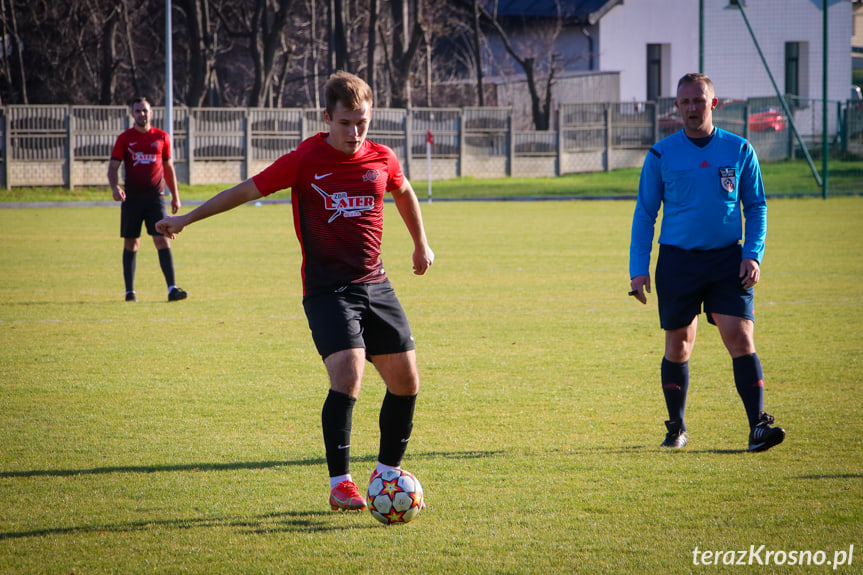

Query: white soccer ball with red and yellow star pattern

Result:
[366,469,425,525]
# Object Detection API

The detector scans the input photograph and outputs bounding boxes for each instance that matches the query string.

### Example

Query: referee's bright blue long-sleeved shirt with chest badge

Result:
[629,128,767,278]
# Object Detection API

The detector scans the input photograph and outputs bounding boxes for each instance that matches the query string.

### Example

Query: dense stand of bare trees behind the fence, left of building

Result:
[0,0,572,113]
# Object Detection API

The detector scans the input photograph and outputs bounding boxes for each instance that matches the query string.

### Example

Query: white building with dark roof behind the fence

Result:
[487,0,854,108]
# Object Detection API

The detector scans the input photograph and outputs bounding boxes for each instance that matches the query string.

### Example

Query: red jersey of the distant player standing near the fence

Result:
[111,128,171,198]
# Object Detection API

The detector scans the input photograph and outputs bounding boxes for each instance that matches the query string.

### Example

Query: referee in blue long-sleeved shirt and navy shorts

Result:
[629,74,785,451]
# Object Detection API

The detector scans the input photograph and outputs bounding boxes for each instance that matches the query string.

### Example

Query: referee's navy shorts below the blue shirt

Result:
[656,244,755,330]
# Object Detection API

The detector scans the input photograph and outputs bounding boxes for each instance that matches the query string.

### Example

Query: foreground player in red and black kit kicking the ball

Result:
[156,72,434,509]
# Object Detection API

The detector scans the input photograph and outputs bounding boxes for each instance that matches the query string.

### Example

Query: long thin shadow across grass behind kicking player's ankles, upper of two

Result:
[0,451,505,479]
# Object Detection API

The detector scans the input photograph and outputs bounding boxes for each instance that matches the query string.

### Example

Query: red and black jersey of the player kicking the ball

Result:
[253,133,405,294]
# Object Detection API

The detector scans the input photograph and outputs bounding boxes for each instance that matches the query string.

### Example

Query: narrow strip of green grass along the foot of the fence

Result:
[0,156,863,203]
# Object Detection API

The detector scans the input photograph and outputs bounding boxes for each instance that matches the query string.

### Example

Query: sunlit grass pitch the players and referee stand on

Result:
[0,198,863,574]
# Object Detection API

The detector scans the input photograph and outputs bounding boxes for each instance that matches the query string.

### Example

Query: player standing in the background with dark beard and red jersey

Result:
[108,98,187,301]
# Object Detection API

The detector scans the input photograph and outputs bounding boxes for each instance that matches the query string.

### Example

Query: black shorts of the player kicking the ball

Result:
[303,281,414,358]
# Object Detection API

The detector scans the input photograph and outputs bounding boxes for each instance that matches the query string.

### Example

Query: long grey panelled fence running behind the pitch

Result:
[0,98,863,188]
